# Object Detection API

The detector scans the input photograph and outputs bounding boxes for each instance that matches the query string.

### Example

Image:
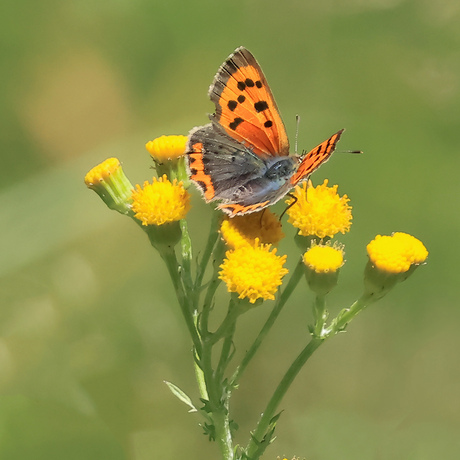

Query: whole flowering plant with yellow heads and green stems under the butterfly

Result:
[85,131,428,460]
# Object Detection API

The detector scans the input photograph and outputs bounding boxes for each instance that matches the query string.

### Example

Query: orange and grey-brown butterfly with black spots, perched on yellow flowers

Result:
[186,47,344,217]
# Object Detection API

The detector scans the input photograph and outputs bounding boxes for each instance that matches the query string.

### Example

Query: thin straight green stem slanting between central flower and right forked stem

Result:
[230,261,303,387]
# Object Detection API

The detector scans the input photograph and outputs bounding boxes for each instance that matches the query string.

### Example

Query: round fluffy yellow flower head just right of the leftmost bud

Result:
[132,175,190,225]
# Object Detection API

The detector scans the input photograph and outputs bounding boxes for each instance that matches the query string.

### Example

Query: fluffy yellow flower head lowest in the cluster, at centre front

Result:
[219,241,288,303]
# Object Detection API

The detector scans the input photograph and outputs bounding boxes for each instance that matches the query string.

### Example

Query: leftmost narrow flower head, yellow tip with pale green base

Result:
[85,158,133,214]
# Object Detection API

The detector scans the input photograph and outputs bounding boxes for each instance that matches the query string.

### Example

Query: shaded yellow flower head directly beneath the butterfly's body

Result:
[220,209,284,248]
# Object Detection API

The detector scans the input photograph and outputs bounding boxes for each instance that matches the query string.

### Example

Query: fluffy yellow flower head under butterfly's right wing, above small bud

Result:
[286,179,352,238]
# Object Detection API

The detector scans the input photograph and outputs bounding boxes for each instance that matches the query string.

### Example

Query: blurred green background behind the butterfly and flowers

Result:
[0,0,460,460]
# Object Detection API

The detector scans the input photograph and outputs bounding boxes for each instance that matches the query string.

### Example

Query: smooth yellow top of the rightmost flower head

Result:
[367,232,428,273]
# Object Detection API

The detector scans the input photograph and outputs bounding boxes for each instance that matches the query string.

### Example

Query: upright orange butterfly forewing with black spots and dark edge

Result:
[209,47,289,156]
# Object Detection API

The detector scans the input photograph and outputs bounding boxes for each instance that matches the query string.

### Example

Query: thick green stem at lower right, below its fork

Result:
[246,339,324,460]
